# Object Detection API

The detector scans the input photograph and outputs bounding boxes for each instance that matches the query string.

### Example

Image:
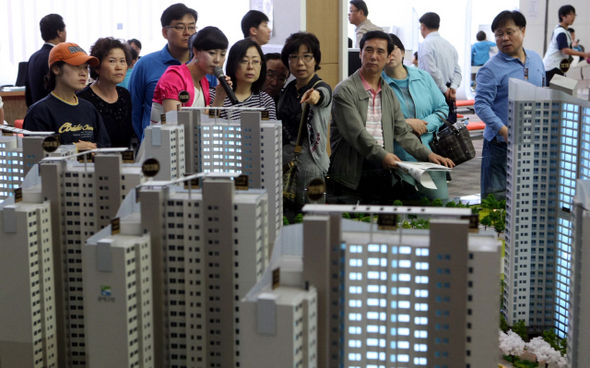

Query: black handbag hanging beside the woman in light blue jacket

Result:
[430,115,475,165]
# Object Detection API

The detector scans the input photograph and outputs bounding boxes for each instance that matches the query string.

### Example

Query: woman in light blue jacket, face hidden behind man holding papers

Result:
[382,33,449,202]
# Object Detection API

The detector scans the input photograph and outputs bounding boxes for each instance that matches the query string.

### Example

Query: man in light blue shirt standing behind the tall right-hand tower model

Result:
[475,10,545,200]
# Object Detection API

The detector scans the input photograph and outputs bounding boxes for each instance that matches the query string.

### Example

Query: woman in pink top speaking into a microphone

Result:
[151,27,229,123]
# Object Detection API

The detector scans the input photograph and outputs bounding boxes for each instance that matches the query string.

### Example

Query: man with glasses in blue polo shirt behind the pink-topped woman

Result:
[129,4,197,140]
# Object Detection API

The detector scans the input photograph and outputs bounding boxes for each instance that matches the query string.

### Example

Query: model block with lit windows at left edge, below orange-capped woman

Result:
[0,124,76,201]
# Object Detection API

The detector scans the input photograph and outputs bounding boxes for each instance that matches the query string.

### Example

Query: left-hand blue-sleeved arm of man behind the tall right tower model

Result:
[474,67,508,136]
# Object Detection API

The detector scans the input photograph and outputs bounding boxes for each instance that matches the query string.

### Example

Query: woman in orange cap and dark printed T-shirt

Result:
[24,42,111,151]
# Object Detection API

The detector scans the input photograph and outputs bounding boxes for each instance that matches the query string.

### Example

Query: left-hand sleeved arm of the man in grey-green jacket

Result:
[332,86,390,163]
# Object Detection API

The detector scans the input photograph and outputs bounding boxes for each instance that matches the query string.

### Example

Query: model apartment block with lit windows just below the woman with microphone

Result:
[138,108,283,249]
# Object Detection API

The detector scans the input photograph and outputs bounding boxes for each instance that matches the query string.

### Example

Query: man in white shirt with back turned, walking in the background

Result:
[418,12,461,121]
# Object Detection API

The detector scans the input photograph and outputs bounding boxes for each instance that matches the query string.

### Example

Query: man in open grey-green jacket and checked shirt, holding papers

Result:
[330,31,455,204]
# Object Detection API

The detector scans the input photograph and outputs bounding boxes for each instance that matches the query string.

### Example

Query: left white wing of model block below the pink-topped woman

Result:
[142,123,187,180]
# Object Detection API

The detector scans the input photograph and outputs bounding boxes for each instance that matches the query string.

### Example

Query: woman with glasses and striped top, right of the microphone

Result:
[211,38,277,120]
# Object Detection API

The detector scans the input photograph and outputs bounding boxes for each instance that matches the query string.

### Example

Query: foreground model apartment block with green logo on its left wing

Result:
[83,173,268,367]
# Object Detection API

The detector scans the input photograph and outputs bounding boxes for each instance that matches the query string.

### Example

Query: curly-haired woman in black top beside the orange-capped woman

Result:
[77,37,135,147]
